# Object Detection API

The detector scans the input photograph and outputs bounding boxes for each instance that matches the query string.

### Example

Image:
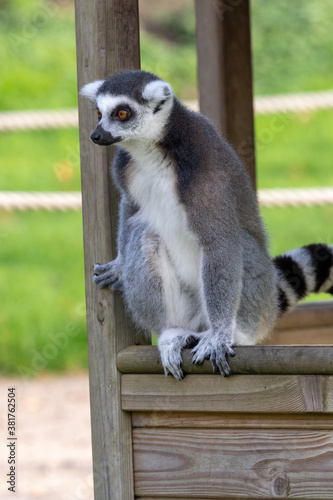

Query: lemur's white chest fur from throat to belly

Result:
[122,144,201,288]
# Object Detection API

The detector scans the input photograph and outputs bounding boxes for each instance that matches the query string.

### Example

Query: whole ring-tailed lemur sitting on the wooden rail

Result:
[81,70,333,379]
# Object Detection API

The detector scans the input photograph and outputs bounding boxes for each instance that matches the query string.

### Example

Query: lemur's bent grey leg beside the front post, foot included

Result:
[123,230,207,379]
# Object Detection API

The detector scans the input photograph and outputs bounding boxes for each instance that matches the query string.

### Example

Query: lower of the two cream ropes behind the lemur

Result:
[0,187,333,212]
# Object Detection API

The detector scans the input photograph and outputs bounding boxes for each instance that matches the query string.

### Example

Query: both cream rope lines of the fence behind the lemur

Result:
[0,90,333,211]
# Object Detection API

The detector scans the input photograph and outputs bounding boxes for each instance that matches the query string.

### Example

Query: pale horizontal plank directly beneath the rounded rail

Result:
[121,375,331,413]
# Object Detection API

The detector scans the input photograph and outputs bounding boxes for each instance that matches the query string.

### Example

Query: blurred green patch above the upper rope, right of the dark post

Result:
[251,0,333,95]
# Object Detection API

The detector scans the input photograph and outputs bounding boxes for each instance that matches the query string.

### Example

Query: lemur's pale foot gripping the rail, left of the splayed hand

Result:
[158,328,197,380]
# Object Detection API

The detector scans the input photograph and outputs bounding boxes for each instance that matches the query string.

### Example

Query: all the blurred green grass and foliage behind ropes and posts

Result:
[0,0,333,375]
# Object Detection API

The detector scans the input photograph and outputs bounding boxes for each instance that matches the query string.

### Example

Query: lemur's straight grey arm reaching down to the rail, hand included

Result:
[190,182,243,375]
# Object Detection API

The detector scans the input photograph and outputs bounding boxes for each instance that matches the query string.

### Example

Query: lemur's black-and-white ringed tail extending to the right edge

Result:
[273,243,333,315]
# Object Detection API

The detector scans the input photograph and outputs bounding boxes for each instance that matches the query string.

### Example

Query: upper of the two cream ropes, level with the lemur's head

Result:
[0,90,333,132]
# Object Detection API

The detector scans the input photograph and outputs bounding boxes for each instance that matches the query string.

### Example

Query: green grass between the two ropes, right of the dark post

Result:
[256,109,333,188]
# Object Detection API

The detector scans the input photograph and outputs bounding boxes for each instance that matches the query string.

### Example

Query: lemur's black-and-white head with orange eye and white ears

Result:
[80,70,174,146]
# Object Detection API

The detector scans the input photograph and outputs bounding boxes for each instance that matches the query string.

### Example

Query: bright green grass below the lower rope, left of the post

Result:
[0,212,87,375]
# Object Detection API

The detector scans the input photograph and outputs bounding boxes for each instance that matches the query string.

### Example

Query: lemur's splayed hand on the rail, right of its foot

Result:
[192,330,235,377]
